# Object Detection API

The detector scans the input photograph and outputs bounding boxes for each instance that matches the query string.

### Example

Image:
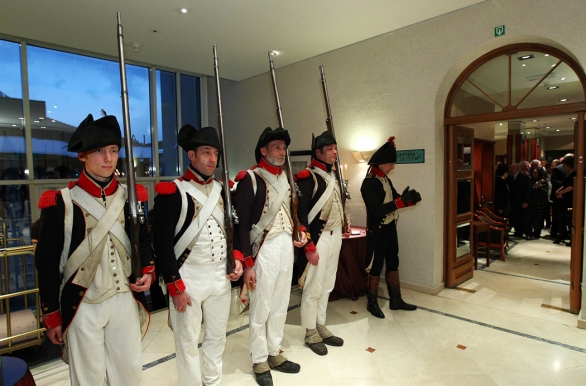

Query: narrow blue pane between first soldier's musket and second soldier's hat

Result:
[157,70,179,176]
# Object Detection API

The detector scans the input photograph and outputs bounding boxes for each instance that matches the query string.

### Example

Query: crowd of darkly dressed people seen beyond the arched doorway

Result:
[494,153,576,246]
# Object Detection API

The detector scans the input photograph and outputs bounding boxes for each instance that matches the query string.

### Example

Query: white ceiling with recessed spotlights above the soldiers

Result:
[0,0,486,80]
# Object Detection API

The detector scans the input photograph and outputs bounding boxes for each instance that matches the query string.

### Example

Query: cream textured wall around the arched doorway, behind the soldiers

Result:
[209,0,586,292]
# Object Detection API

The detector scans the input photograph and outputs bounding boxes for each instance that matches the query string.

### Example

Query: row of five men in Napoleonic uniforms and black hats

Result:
[35,115,421,386]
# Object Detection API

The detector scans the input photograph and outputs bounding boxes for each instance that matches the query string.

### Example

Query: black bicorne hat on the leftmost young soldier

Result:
[67,114,122,153]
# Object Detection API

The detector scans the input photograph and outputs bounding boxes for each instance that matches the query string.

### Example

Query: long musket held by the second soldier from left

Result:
[214,44,238,275]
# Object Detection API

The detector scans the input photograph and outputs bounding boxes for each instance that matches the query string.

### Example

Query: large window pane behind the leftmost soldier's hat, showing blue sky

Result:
[27,46,152,179]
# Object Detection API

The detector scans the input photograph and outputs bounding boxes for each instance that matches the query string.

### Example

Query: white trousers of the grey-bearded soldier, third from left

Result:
[249,232,293,363]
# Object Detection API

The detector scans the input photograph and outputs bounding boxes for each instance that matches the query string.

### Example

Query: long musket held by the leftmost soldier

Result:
[116,12,144,280]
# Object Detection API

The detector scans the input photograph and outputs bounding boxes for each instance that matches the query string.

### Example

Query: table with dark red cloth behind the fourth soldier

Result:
[330,226,367,301]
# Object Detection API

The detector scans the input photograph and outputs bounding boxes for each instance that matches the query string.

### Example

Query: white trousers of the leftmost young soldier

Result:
[67,292,142,386]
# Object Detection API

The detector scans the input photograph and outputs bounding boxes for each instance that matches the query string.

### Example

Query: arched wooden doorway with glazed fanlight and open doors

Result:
[444,43,586,313]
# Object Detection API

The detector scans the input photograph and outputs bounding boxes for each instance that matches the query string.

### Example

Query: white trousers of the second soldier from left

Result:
[169,258,230,385]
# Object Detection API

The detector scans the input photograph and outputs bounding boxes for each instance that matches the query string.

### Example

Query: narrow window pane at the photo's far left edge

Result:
[0,40,27,178]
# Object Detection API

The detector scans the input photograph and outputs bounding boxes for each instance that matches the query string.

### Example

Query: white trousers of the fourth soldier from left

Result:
[301,226,342,329]
